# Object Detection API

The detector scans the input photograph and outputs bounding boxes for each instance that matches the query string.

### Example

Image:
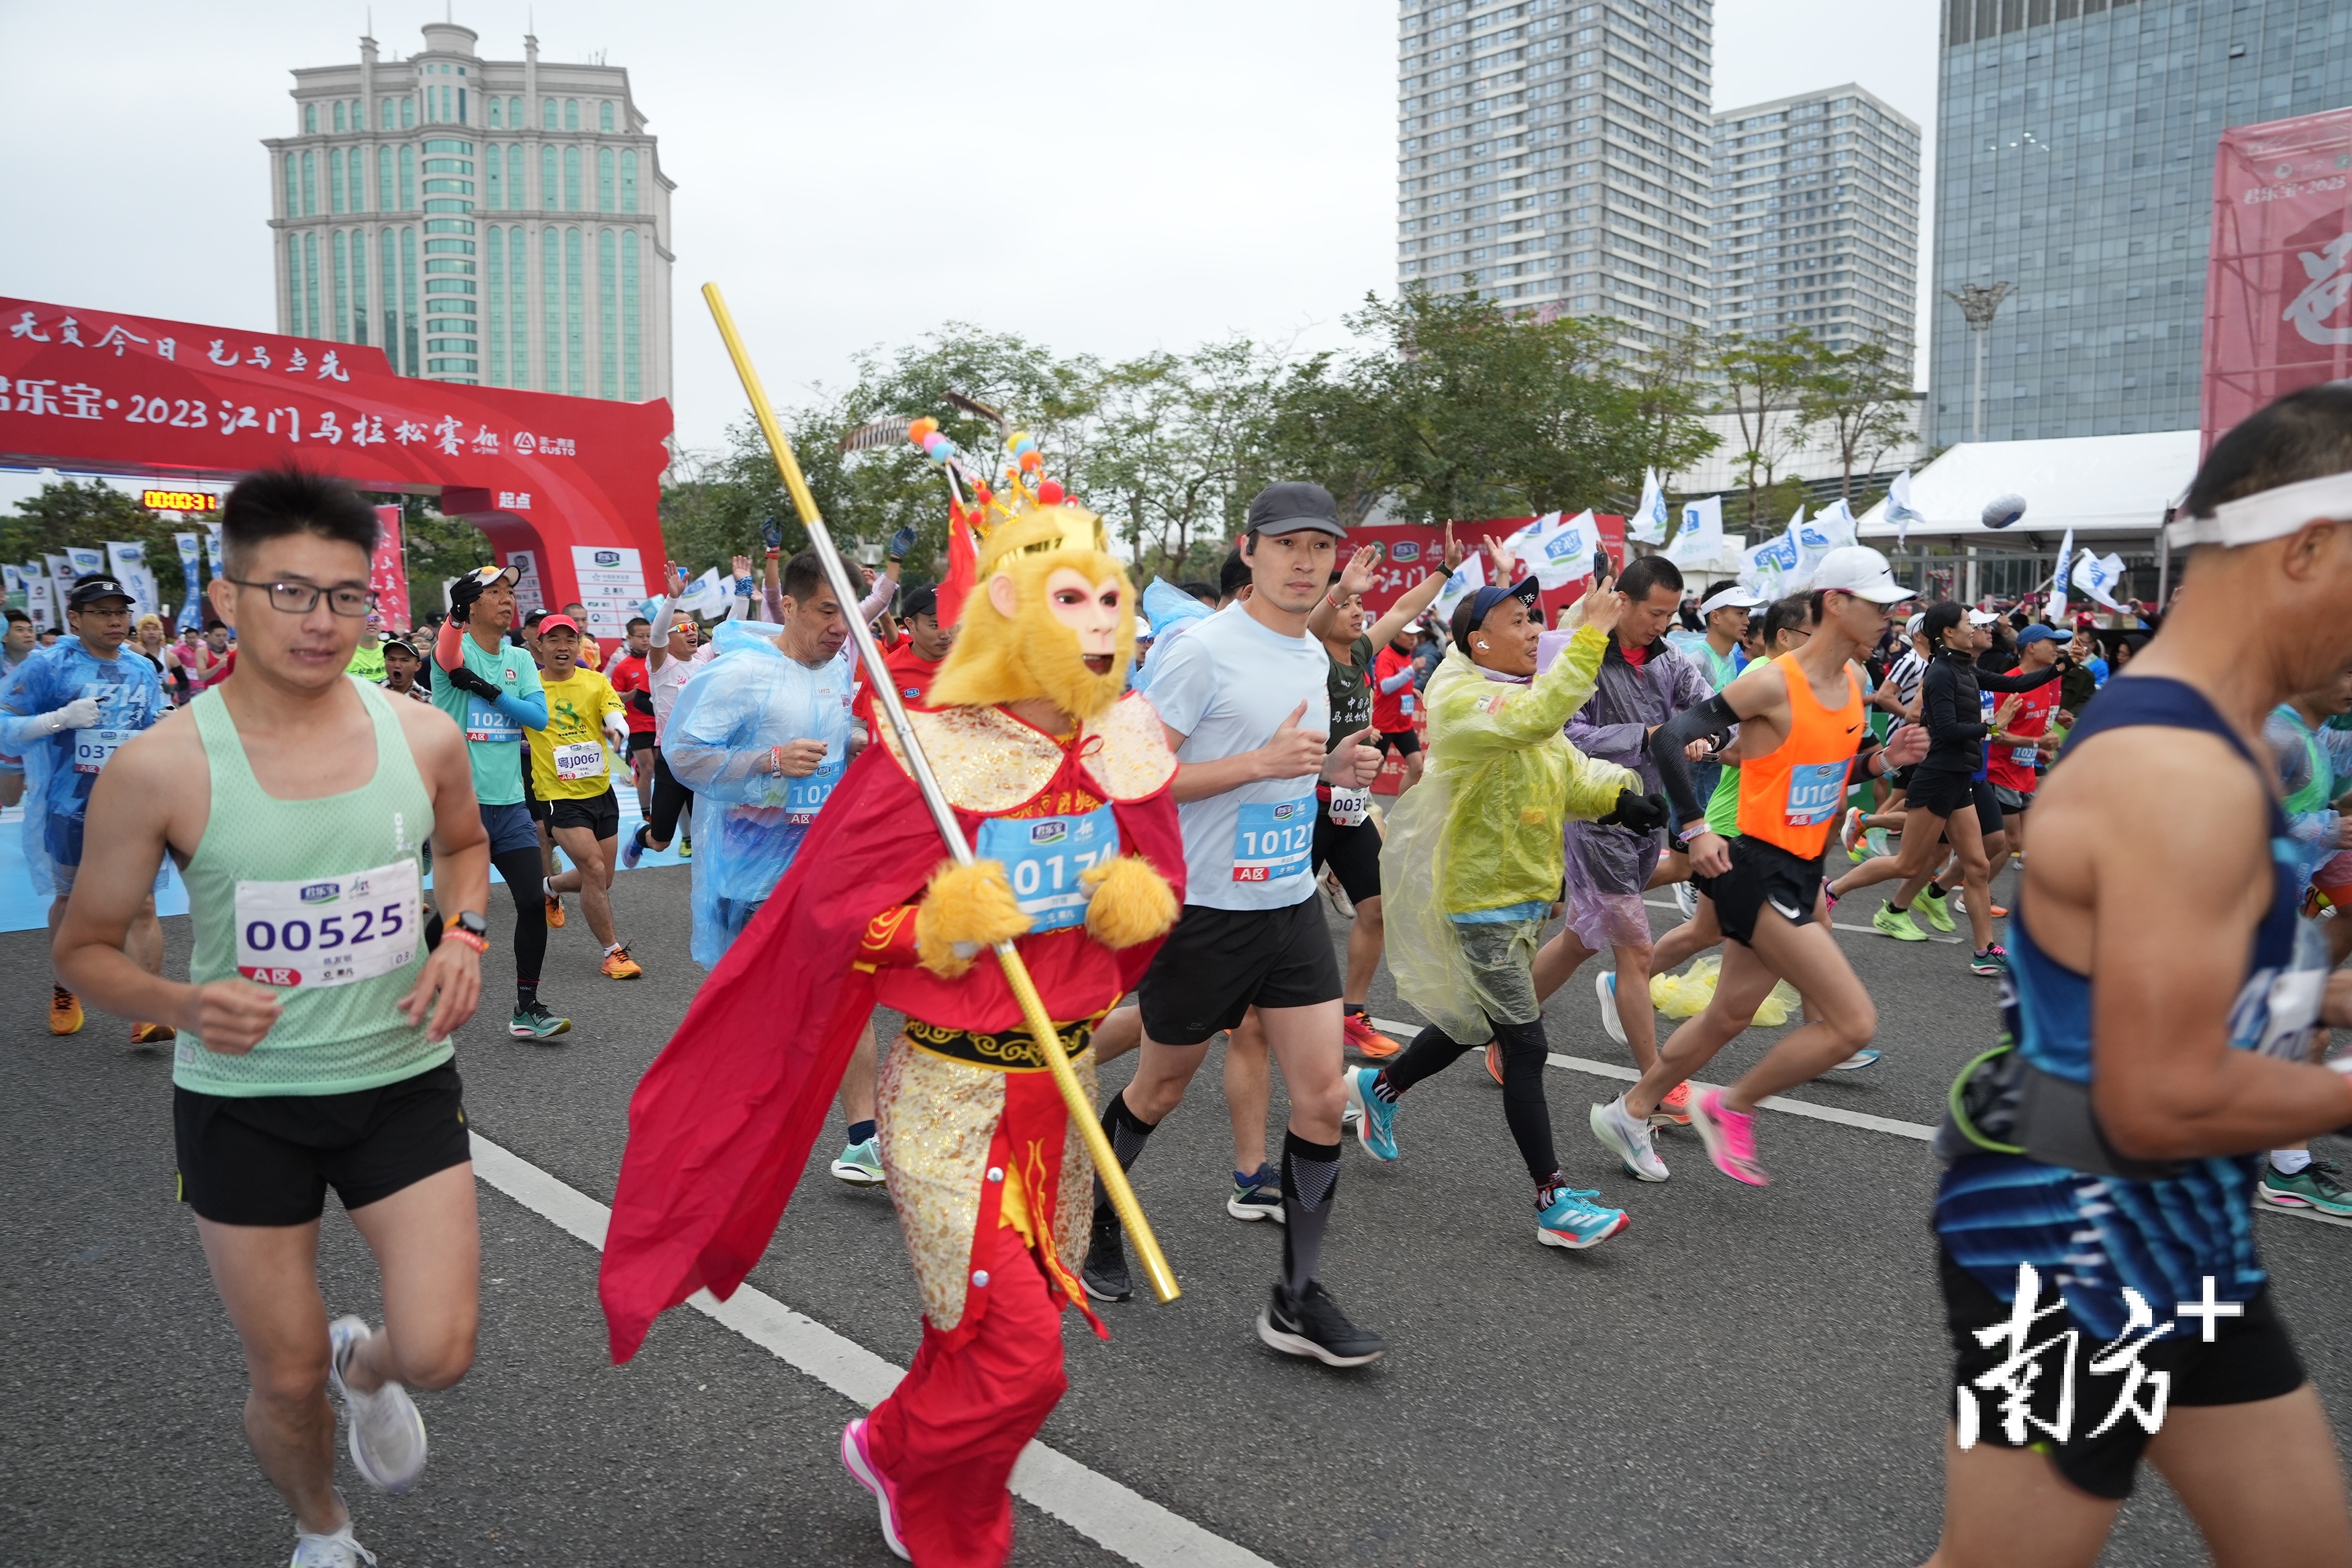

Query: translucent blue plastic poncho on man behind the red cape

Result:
[661,621,856,969]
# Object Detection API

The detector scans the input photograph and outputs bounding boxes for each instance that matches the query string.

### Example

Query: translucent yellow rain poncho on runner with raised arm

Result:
[1381,628,1642,1041]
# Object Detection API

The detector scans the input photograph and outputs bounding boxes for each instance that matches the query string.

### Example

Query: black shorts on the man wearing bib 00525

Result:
[172,1063,473,1225]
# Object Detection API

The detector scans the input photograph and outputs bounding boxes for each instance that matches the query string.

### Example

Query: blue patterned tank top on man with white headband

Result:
[1936,677,2329,1340]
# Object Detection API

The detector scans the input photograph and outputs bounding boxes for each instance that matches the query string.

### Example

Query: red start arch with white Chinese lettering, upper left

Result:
[0,296,671,637]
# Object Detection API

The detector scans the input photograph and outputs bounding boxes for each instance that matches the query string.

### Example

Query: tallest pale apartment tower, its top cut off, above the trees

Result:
[1397,0,1714,346]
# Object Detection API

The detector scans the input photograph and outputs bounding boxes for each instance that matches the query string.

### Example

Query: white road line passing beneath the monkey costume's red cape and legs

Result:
[473,1133,1273,1568]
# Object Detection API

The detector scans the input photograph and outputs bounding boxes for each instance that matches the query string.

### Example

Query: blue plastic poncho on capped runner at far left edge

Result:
[0,637,169,898]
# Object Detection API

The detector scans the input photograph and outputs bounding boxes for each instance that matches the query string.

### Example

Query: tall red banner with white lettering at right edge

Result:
[2199,108,2352,449]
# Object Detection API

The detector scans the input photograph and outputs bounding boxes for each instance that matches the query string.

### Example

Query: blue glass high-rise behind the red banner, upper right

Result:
[1926,0,2352,444]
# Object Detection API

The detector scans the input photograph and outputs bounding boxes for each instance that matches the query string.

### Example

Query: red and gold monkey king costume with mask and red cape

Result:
[602,505,1183,1565]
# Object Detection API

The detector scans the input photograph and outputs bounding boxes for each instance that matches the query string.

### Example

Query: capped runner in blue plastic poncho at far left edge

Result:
[0,574,172,1046]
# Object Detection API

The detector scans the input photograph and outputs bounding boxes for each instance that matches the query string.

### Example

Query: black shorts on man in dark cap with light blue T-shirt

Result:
[1136,898,1340,1046]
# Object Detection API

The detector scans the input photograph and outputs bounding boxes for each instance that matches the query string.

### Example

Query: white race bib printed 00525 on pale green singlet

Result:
[238,861,424,989]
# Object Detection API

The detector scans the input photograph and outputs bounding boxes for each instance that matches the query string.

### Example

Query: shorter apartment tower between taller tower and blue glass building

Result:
[1708,83,1919,376]
